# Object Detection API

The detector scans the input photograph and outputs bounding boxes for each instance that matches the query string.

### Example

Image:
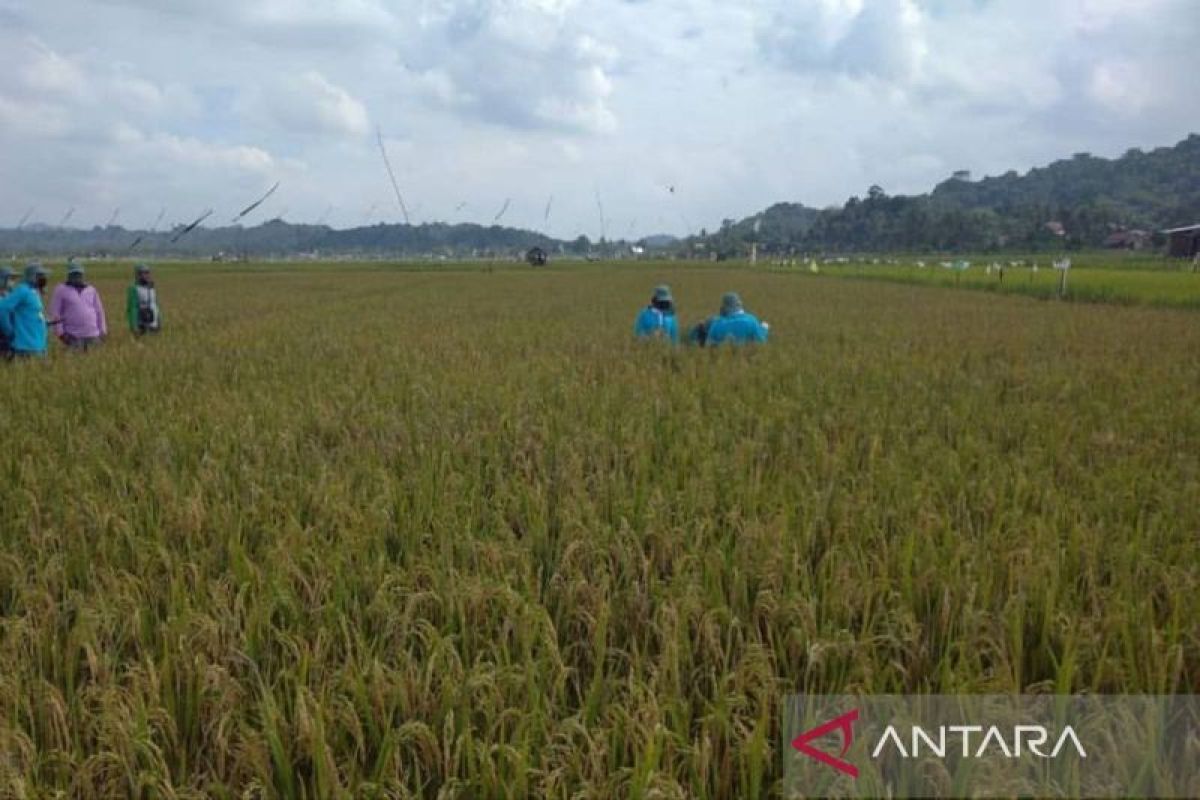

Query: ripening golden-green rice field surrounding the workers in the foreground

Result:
[0,266,1200,798]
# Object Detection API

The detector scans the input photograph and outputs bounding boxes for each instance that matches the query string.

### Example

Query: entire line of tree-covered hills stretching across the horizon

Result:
[9,134,1200,258]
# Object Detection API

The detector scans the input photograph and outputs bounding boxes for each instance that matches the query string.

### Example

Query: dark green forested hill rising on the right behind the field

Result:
[706,134,1200,257]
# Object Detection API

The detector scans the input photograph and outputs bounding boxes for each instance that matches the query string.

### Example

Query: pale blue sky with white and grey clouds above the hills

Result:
[0,0,1200,237]
